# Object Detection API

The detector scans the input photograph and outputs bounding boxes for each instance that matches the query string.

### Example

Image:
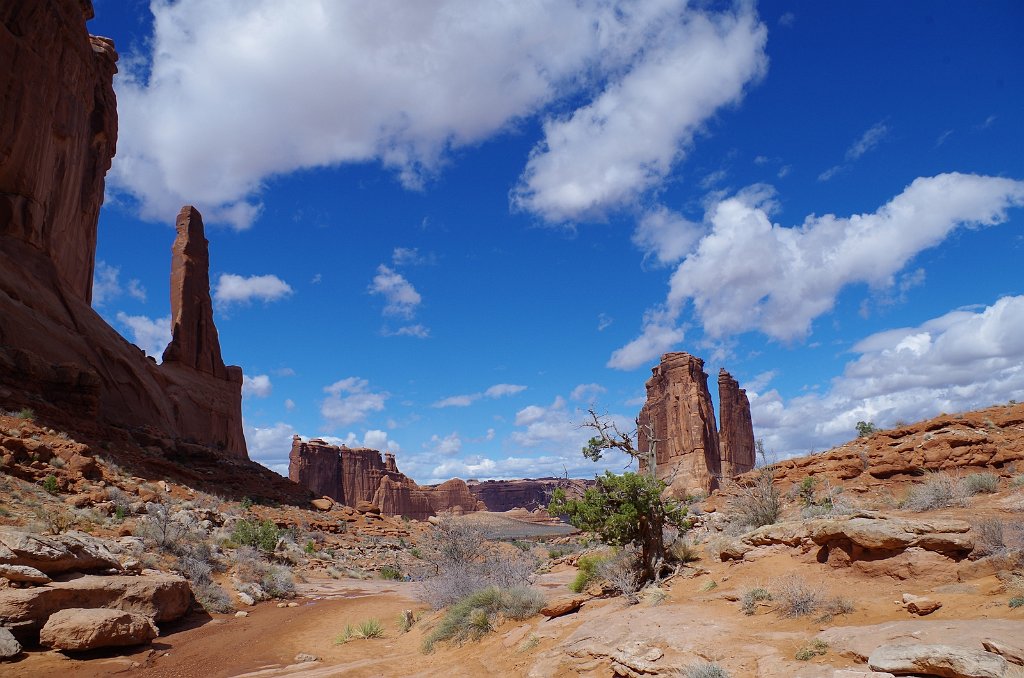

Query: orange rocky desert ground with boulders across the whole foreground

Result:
[0,405,1024,677]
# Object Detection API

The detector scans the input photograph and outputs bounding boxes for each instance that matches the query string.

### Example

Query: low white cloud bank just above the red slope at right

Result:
[748,296,1024,455]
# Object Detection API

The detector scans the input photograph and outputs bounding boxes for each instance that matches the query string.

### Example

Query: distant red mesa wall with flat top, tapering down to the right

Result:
[288,435,484,520]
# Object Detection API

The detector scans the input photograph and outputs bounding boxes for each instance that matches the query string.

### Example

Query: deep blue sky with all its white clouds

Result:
[89,0,1024,482]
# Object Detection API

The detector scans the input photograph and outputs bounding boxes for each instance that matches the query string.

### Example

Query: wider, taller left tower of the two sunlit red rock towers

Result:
[637,352,722,496]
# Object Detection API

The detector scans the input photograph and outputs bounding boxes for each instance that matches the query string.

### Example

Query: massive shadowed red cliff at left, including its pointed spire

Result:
[0,0,253,473]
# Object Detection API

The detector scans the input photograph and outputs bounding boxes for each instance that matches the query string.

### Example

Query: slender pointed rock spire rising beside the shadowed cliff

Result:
[164,205,226,379]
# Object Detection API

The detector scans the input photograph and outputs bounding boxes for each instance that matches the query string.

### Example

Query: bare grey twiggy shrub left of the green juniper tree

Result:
[420,516,537,609]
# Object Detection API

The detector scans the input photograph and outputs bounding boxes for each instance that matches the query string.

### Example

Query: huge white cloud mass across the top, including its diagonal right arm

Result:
[110,0,766,228]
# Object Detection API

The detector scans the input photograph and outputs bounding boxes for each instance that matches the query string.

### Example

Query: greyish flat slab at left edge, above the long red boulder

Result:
[0,527,121,575]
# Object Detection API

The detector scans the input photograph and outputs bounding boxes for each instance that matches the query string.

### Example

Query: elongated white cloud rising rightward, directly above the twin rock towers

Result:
[608,173,1024,369]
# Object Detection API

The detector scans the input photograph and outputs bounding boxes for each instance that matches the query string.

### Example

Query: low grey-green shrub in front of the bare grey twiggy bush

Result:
[423,587,544,652]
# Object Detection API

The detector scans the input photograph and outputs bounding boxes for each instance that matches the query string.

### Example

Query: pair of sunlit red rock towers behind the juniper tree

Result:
[637,352,754,497]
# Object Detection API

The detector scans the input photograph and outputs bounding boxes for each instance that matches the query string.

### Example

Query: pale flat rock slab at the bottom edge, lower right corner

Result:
[867,643,1010,678]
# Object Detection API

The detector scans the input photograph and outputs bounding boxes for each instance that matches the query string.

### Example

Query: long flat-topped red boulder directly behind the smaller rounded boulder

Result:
[0,570,191,643]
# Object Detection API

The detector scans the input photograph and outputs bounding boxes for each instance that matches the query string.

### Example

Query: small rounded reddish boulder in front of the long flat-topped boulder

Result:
[39,607,158,651]
